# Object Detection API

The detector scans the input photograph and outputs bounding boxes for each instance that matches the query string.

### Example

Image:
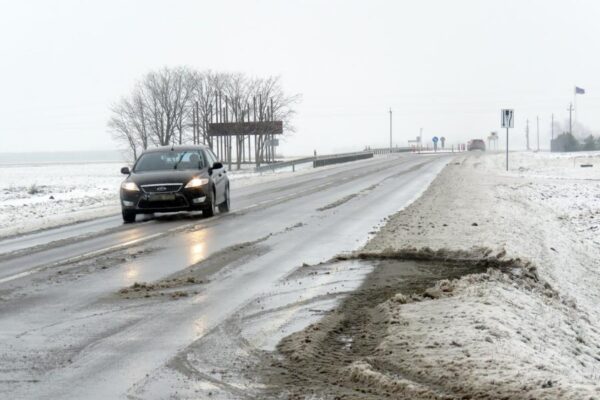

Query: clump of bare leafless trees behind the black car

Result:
[108,67,300,162]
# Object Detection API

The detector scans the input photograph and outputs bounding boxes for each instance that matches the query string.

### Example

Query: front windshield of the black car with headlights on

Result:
[134,150,206,172]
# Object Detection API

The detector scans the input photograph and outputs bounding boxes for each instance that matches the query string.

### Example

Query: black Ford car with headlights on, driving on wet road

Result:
[121,146,230,223]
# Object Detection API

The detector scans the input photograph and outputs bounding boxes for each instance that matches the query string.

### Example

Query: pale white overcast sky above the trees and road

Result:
[0,0,600,155]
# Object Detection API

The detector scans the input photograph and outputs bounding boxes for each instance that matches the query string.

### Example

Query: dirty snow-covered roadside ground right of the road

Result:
[355,153,600,399]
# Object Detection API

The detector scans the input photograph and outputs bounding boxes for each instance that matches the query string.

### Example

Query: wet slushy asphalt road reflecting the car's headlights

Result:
[0,154,451,399]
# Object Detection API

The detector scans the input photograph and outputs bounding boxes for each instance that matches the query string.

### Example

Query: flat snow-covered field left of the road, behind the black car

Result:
[0,156,356,238]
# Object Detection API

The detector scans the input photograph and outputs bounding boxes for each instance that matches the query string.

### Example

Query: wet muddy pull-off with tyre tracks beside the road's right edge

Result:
[135,260,486,399]
